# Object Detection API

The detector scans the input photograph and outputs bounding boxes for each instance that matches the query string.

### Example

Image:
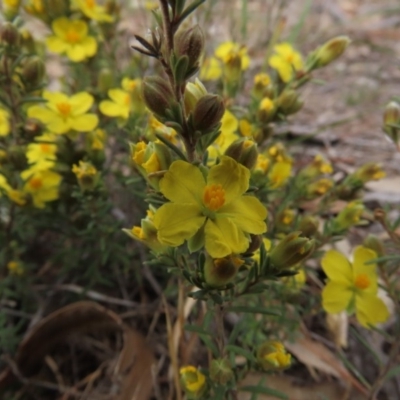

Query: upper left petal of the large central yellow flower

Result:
[160,160,206,203]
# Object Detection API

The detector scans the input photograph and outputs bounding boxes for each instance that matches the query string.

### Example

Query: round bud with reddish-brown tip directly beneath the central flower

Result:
[204,256,244,288]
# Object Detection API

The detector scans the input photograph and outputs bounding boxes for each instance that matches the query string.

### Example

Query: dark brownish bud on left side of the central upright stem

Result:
[142,76,175,119]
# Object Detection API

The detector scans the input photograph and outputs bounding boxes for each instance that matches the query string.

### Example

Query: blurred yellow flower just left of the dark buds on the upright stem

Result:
[99,78,144,119]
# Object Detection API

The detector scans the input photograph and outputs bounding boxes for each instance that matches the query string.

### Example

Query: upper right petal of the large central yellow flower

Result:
[207,156,250,204]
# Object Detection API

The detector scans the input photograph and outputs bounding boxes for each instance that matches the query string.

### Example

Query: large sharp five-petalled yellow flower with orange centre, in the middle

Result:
[154,156,267,258]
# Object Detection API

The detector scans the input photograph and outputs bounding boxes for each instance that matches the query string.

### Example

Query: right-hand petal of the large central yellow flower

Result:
[219,196,267,235]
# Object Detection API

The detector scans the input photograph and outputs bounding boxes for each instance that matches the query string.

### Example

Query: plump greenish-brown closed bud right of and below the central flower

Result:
[270,232,315,269]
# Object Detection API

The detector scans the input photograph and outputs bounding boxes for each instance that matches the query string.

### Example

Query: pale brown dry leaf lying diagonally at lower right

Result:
[285,336,366,394]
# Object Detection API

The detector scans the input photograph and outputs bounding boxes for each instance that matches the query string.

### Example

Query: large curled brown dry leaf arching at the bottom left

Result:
[0,301,153,400]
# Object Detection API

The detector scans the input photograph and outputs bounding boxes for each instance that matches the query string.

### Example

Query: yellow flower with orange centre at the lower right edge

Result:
[321,246,389,327]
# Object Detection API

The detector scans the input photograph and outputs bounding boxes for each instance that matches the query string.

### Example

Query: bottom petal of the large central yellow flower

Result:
[204,217,249,258]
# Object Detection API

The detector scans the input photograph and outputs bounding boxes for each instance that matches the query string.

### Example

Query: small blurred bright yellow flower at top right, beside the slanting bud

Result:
[269,43,303,83]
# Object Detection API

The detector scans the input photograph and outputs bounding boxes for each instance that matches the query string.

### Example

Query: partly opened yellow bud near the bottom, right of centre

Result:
[257,340,291,371]
